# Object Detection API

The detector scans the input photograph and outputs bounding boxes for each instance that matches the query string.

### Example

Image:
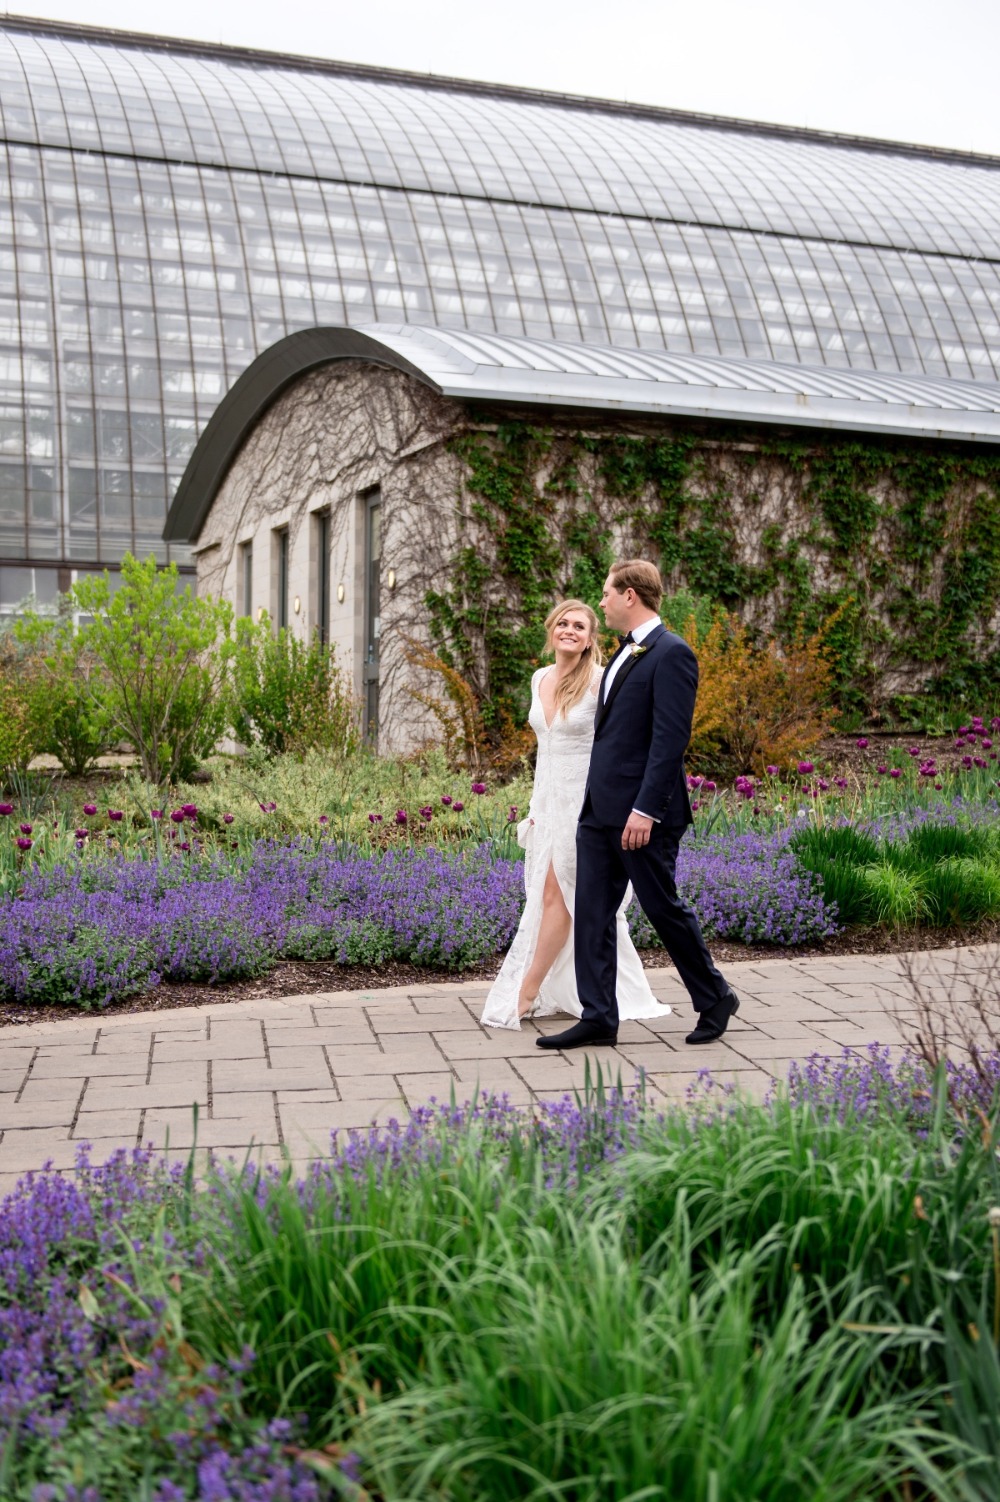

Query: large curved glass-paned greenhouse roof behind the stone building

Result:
[0,18,1000,579]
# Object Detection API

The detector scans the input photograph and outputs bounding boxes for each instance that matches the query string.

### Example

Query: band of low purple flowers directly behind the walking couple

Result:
[0,832,835,1006]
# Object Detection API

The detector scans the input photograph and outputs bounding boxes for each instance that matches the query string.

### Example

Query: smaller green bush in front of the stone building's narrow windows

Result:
[231,619,360,756]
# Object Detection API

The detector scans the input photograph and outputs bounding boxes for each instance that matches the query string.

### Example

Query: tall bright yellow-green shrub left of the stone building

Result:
[71,553,233,784]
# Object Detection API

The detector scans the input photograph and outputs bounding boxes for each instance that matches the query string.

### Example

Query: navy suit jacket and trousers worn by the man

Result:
[574,625,730,1032]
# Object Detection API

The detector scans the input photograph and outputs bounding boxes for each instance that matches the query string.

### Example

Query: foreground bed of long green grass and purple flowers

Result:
[0,1053,1000,1502]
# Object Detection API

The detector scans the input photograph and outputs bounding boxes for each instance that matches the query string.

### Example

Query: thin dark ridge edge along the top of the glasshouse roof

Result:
[7,14,1000,167]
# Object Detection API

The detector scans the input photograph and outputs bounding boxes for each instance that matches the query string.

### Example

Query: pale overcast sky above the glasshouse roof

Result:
[7,0,1000,155]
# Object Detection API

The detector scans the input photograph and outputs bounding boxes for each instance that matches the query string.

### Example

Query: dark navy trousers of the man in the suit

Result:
[574,816,730,1032]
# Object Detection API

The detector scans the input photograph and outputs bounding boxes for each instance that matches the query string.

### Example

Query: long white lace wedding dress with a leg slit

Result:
[482,668,670,1027]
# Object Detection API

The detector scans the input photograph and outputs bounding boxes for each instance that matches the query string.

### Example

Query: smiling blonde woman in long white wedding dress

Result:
[482,599,670,1027]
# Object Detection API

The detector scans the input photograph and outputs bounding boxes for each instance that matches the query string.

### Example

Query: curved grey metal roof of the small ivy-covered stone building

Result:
[164,323,1000,542]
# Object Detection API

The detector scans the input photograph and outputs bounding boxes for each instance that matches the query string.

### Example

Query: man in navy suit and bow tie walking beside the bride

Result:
[538,559,739,1048]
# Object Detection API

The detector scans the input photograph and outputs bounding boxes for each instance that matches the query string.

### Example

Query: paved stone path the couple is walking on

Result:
[0,948,1000,1193]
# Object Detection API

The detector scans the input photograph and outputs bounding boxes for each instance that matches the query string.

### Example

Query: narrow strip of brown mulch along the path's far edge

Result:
[0,919,1000,1027]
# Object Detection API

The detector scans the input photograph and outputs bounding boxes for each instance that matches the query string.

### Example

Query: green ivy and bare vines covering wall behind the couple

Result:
[428,422,1000,725]
